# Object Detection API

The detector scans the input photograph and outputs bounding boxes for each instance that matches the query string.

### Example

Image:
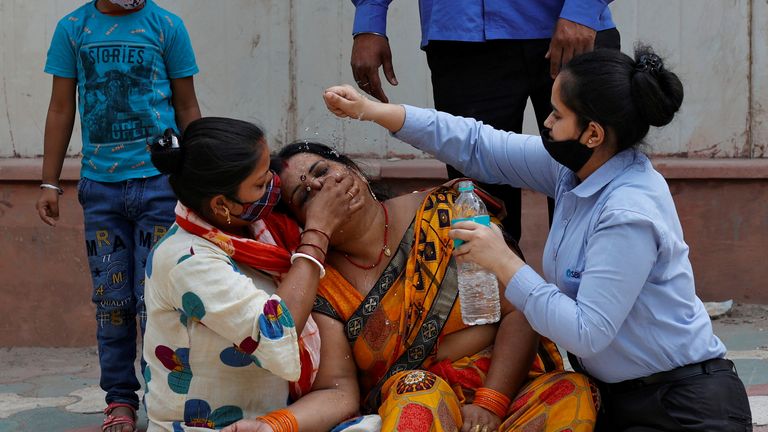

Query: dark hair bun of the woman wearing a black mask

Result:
[631,45,683,126]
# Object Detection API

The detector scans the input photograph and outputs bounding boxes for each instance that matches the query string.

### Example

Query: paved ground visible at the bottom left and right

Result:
[0,305,768,432]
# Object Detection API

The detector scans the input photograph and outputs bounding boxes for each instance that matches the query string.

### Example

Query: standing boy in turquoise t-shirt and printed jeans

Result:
[37,0,200,432]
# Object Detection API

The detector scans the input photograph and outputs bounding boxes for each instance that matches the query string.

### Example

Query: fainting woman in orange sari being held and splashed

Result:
[272,143,598,432]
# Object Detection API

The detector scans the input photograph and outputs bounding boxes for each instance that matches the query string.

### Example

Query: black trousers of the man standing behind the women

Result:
[426,29,620,241]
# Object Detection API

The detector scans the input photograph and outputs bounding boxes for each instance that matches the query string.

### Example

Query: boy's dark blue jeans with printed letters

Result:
[77,175,176,409]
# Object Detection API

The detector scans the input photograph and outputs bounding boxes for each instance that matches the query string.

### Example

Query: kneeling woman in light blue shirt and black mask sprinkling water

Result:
[324,47,751,431]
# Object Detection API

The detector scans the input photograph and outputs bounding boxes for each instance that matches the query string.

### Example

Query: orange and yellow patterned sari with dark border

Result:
[315,186,596,432]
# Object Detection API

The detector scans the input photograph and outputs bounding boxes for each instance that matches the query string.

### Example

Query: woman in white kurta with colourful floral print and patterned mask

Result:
[144,118,360,432]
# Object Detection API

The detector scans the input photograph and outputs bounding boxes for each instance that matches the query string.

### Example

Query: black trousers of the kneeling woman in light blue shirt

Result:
[595,364,752,432]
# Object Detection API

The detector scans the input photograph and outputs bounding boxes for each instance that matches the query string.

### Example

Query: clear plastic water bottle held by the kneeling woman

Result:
[451,181,501,325]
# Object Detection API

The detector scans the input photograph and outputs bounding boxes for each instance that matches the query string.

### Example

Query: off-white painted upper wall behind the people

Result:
[0,0,768,158]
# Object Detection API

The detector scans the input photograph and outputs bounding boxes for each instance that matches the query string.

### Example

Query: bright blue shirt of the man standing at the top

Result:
[352,0,615,47]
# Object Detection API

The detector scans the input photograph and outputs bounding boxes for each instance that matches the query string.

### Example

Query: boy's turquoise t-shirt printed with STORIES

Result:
[45,0,198,182]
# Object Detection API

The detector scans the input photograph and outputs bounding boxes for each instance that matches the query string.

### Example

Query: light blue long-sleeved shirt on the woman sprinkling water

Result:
[395,106,726,383]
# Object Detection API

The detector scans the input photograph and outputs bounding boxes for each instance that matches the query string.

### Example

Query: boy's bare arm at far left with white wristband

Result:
[35,76,77,226]
